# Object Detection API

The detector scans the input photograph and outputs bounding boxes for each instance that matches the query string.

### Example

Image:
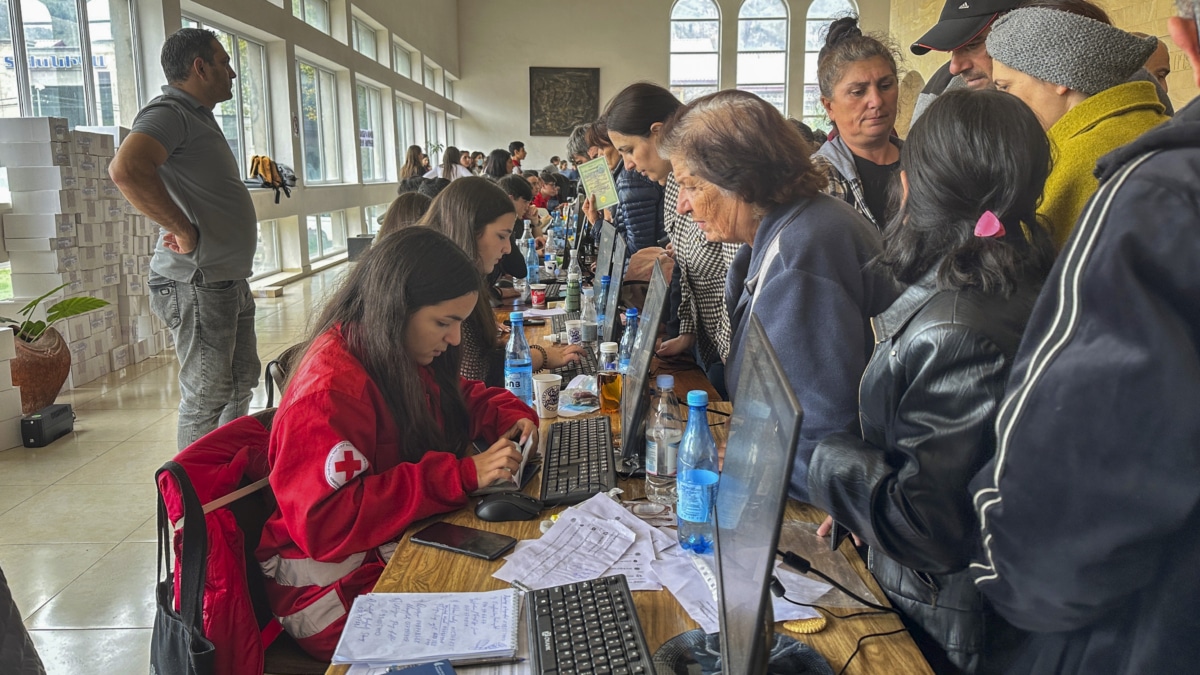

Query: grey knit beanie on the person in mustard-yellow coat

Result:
[988,7,1158,96]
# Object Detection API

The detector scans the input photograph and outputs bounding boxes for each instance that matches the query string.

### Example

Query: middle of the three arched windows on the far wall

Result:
[738,0,792,115]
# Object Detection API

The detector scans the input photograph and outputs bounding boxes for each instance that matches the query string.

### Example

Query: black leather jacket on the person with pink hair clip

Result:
[809,268,1039,673]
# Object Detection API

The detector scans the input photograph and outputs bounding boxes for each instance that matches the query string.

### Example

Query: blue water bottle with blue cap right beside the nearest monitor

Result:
[676,390,719,555]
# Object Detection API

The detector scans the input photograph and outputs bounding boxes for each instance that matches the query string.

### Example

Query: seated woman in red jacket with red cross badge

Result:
[258,227,538,659]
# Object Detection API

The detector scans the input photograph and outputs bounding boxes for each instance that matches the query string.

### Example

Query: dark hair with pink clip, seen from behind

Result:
[877,90,1055,297]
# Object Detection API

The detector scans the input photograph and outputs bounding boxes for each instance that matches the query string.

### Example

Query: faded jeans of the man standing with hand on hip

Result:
[149,274,262,449]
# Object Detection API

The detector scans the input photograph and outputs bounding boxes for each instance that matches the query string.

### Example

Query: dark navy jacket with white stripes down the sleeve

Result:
[972,101,1200,675]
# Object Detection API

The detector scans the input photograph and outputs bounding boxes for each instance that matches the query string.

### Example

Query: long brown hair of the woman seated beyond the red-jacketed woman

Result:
[418,175,516,357]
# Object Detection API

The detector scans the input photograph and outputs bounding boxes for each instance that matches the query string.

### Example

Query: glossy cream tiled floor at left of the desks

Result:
[0,265,346,675]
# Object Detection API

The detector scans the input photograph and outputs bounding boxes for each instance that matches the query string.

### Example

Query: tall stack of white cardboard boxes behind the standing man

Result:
[0,118,166,386]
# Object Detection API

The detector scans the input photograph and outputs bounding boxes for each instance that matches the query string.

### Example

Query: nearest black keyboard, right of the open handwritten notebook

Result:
[526,574,654,675]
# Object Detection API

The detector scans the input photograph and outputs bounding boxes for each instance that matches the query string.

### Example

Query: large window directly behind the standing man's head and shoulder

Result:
[184,17,271,175]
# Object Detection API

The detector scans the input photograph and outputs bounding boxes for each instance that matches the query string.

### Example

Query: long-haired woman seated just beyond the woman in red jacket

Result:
[418,177,583,387]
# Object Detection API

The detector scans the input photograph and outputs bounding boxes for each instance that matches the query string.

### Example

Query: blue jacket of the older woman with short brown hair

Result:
[725,195,899,501]
